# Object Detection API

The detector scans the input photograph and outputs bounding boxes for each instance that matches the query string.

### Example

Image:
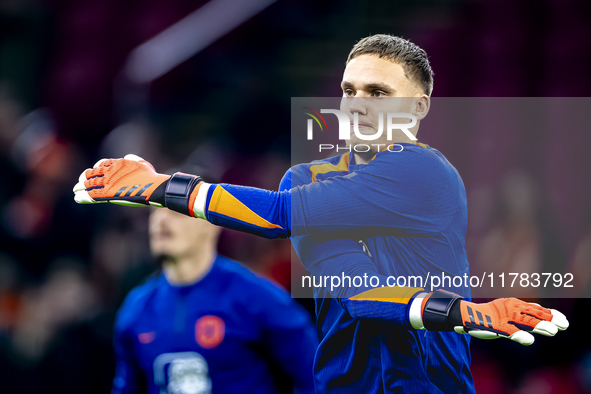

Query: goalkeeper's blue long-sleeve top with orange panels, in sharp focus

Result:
[193,143,474,393]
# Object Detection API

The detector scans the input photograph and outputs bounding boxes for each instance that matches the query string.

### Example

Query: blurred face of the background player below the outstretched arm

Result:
[149,208,220,261]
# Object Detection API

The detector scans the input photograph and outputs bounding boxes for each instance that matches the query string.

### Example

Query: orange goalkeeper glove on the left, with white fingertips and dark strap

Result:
[74,155,202,216]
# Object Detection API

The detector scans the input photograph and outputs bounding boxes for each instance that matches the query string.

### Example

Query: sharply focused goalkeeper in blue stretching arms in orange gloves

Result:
[74,35,568,393]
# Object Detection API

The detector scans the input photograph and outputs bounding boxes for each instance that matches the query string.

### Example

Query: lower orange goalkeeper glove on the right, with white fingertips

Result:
[410,290,569,345]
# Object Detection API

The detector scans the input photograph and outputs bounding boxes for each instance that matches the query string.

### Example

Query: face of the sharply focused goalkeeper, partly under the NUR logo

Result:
[341,55,429,154]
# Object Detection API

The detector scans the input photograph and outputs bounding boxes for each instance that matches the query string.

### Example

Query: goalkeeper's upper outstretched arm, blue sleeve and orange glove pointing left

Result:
[74,150,459,238]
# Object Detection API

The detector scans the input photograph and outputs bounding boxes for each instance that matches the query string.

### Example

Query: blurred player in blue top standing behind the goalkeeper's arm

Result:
[112,169,318,394]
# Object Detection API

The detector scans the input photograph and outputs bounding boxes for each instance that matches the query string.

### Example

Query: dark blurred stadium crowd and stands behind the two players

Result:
[0,0,591,394]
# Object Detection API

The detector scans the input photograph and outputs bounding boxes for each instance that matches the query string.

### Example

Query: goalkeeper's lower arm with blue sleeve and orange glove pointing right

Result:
[302,239,569,345]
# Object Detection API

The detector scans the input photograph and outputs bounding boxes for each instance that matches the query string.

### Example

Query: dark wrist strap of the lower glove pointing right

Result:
[423,290,463,331]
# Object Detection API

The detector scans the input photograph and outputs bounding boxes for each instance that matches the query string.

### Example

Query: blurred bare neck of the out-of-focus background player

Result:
[162,245,216,285]
